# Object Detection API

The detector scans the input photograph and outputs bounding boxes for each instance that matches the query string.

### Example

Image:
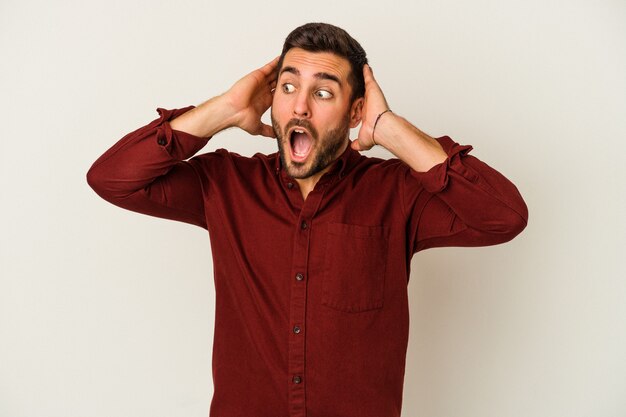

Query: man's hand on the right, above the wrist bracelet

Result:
[350,64,389,151]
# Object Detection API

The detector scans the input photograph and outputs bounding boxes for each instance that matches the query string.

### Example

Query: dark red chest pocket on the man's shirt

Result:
[322,223,389,313]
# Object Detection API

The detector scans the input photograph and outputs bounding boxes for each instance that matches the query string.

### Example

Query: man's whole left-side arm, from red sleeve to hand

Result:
[87,59,278,228]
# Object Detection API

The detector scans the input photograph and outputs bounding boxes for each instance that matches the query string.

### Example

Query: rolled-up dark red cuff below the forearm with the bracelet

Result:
[411,136,478,194]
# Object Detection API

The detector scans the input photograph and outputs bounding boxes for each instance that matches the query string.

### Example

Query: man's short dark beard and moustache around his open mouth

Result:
[271,110,350,179]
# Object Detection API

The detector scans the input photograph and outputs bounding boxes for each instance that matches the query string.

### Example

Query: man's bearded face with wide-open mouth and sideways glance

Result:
[271,48,363,179]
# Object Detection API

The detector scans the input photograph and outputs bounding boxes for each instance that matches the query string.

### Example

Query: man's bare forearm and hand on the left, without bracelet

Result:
[170,57,278,138]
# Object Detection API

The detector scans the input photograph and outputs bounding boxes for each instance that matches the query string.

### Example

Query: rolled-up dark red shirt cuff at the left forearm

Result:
[156,106,211,160]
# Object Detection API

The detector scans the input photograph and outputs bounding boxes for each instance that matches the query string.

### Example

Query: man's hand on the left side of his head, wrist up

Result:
[224,57,279,138]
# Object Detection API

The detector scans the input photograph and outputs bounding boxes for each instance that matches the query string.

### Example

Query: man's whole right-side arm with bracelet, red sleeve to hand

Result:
[351,66,528,253]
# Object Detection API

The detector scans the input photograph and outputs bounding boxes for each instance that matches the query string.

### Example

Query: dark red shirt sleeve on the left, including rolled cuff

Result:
[87,106,210,229]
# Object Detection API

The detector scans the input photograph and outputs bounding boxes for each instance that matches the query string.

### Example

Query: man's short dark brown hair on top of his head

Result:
[278,23,367,102]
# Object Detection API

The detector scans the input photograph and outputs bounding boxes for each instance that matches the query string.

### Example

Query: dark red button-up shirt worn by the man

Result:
[87,107,528,417]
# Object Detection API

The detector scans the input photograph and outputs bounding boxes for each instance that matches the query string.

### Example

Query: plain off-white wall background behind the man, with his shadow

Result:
[0,0,626,417]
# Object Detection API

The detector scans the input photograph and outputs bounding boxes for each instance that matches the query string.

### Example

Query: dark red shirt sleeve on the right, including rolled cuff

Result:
[403,136,528,253]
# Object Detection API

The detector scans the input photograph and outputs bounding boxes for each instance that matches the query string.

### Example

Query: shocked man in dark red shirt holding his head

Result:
[88,24,528,417]
